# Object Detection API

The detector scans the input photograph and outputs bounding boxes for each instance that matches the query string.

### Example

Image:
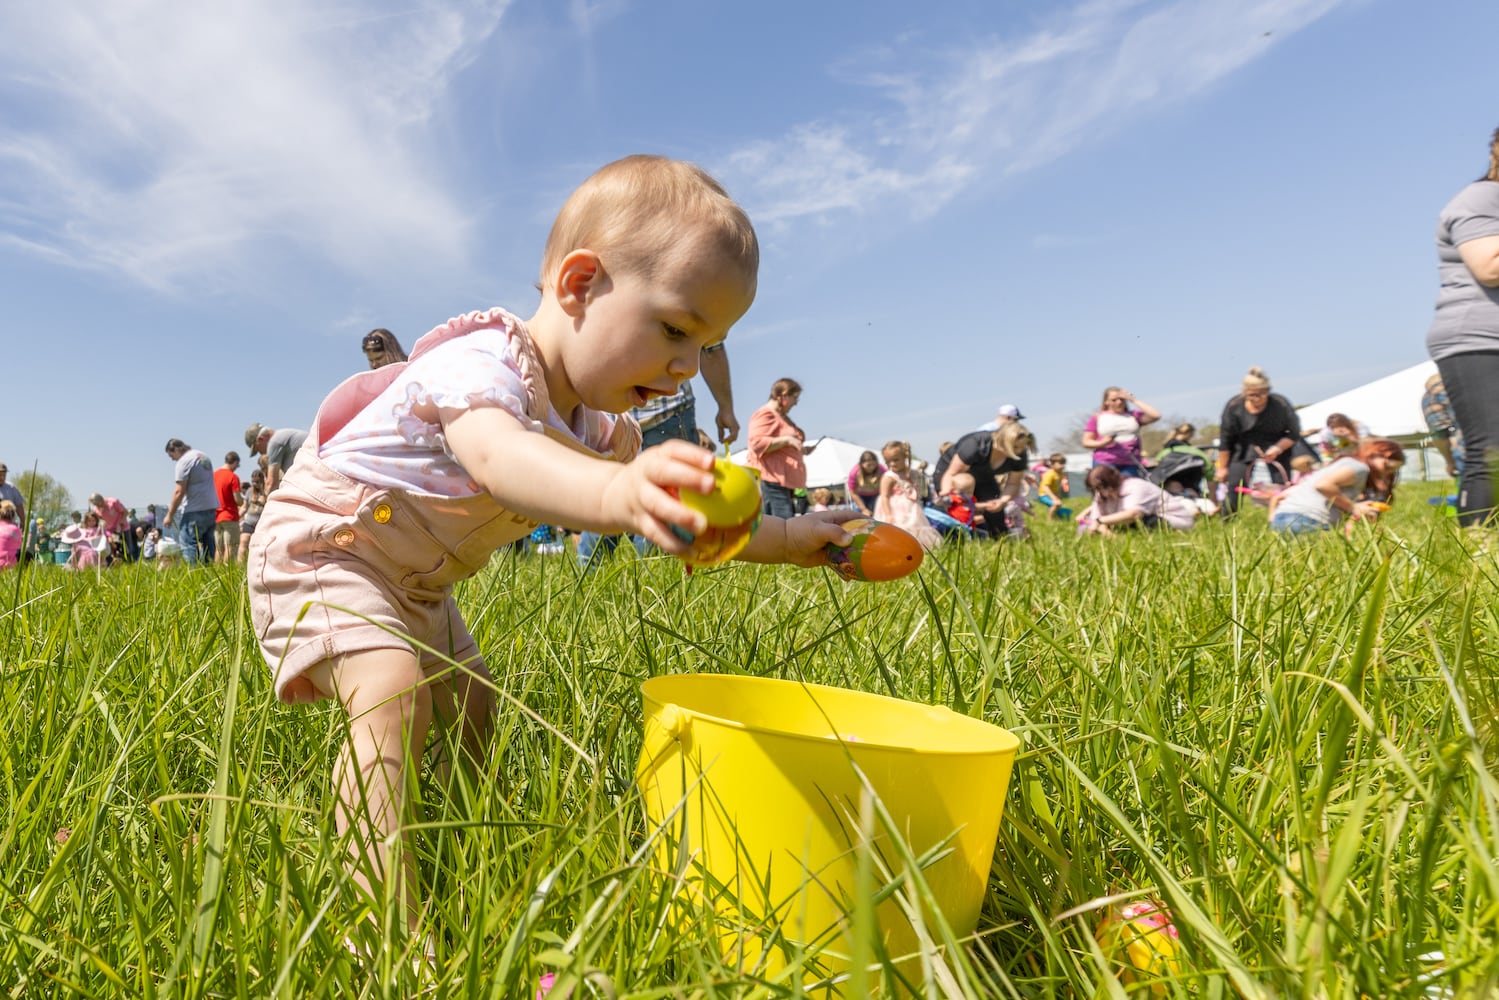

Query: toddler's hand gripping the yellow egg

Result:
[603,441,714,556]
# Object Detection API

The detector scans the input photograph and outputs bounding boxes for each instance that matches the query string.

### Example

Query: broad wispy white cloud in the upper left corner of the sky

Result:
[0,0,508,289]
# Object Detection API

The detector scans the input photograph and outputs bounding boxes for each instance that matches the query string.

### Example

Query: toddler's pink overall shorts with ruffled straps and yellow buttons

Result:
[246,309,640,702]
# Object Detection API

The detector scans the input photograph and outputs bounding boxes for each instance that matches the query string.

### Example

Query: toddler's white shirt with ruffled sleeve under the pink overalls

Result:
[318,330,612,498]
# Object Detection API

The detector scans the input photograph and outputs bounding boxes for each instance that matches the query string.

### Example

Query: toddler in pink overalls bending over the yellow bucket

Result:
[247,156,851,941]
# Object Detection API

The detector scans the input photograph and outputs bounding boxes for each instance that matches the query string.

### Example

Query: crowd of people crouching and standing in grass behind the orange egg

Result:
[731,367,1433,549]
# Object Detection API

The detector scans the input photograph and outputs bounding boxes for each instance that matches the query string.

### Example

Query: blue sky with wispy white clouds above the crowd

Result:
[0,0,1499,507]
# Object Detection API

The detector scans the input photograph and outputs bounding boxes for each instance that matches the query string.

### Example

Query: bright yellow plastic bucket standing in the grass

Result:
[636,675,1019,976]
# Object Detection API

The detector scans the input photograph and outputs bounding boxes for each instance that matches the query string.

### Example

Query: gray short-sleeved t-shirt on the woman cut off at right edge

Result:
[1426,180,1499,361]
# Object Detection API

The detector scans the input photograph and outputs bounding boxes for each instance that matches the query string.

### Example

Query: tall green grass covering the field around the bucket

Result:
[0,490,1499,999]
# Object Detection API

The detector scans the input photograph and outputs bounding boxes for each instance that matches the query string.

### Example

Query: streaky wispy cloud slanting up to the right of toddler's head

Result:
[715,0,1352,226]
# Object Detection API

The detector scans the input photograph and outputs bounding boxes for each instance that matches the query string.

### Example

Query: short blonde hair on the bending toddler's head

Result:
[541,154,760,288]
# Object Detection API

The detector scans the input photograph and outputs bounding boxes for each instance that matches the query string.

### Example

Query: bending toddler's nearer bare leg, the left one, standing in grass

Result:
[307,649,432,928]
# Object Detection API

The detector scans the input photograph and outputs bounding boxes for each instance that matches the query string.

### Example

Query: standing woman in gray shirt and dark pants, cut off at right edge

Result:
[1426,129,1499,528]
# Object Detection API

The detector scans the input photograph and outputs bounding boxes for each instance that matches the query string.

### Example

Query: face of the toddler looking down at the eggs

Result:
[562,241,754,414]
